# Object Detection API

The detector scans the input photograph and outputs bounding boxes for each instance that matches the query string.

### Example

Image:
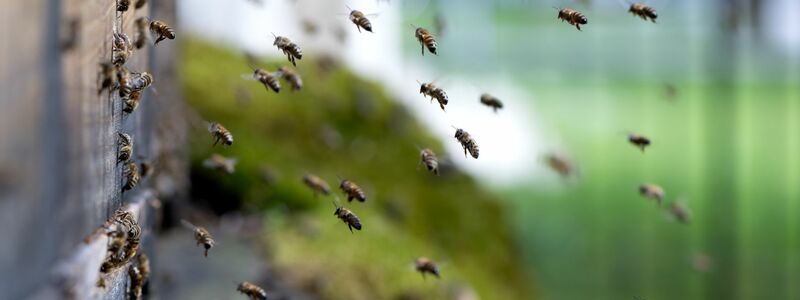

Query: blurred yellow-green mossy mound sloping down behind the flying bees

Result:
[180,41,532,299]
